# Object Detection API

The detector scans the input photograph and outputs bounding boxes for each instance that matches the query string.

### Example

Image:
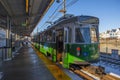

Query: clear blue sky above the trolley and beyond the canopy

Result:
[34,0,120,33]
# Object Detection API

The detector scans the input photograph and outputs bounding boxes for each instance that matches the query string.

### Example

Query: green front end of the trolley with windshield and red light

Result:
[63,18,99,68]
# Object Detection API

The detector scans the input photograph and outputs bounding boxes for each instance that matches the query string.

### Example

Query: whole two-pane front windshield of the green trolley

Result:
[75,27,97,43]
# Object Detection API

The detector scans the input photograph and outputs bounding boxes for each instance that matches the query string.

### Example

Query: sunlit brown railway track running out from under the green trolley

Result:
[70,64,120,80]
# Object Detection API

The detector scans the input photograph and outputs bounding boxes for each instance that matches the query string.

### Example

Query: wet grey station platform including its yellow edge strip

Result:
[1,45,71,80]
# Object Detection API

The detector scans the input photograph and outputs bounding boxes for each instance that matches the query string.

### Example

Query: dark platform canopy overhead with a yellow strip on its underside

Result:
[0,0,54,36]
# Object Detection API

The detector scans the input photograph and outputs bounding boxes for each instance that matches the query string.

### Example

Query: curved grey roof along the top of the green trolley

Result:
[40,15,99,31]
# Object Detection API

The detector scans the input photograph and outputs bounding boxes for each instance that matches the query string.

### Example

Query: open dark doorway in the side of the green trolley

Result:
[56,29,63,62]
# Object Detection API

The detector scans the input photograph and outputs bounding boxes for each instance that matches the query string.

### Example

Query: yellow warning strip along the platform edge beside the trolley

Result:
[32,46,72,80]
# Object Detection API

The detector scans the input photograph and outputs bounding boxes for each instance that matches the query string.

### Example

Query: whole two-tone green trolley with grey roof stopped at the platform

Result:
[34,15,99,68]
